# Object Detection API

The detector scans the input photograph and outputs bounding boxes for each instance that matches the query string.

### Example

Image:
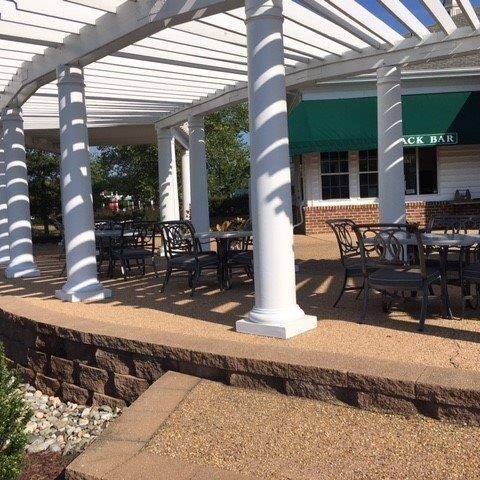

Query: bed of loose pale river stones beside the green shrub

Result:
[22,385,120,455]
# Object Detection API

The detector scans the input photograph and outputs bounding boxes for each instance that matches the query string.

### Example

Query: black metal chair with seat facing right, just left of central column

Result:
[160,220,220,296]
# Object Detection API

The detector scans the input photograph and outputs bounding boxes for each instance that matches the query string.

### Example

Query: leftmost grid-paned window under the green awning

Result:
[320,152,350,200]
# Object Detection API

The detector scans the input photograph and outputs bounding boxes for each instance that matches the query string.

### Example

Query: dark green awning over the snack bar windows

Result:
[288,92,480,155]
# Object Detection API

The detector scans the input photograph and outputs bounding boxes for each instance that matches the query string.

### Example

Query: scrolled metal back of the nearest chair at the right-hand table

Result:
[355,223,427,278]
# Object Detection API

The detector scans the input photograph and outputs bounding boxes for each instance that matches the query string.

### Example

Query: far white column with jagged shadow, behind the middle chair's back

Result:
[157,124,179,222]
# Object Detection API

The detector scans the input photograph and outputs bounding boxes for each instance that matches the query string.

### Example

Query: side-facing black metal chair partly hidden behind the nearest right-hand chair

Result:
[326,218,372,308]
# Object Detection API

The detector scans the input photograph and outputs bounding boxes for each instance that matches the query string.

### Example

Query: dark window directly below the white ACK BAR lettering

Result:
[404,147,438,195]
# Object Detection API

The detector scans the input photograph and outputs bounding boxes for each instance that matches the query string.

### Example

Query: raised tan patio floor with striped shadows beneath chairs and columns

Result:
[0,235,480,371]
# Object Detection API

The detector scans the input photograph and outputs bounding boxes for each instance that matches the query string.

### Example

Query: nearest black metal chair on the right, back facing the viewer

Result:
[354,224,447,331]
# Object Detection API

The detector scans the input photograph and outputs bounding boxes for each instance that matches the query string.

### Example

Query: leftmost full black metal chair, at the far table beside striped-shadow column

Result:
[111,222,158,280]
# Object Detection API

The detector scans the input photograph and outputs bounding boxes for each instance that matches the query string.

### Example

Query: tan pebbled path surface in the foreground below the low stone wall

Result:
[148,381,480,480]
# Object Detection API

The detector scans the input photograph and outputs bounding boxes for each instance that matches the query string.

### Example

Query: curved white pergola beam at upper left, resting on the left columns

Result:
[0,0,244,108]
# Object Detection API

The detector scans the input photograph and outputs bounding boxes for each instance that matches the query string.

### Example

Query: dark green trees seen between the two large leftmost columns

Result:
[27,149,61,236]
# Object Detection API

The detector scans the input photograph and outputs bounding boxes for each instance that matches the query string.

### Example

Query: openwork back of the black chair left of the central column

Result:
[159,220,200,260]
